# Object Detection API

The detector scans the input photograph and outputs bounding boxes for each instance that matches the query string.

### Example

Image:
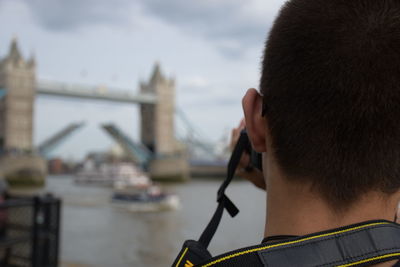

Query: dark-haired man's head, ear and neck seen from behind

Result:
[239,0,400,266]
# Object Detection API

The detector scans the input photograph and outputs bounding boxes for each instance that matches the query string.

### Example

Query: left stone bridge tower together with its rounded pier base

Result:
[0,38,47,186]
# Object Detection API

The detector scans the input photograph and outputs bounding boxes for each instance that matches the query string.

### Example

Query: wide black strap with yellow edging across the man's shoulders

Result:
[196,221,400,267]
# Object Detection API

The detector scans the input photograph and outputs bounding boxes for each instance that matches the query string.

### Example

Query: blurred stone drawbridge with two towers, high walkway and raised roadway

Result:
[0,39,214,183]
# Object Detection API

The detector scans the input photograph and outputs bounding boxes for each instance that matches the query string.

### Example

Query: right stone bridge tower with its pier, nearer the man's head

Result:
[140,63,189,179]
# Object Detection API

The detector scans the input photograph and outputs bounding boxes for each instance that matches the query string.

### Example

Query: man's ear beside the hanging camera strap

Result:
[242,88,267,153]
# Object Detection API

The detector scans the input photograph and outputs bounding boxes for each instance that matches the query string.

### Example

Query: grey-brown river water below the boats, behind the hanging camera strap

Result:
[46,176,265,267]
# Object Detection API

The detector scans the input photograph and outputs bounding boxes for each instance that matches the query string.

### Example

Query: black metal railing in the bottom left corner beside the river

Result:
[0,195,61,267]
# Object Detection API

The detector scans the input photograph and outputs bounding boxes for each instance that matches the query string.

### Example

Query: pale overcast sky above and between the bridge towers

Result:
[0,0,285,158]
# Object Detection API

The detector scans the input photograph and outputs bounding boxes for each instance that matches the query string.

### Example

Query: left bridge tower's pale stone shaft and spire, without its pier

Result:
[0,38,35,151]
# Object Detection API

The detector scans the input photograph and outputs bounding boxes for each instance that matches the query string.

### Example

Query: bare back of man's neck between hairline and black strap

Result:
[265,177,398,237]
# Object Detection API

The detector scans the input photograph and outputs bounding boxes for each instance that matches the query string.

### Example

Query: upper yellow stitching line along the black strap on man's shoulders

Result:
[203,222,389,267]
